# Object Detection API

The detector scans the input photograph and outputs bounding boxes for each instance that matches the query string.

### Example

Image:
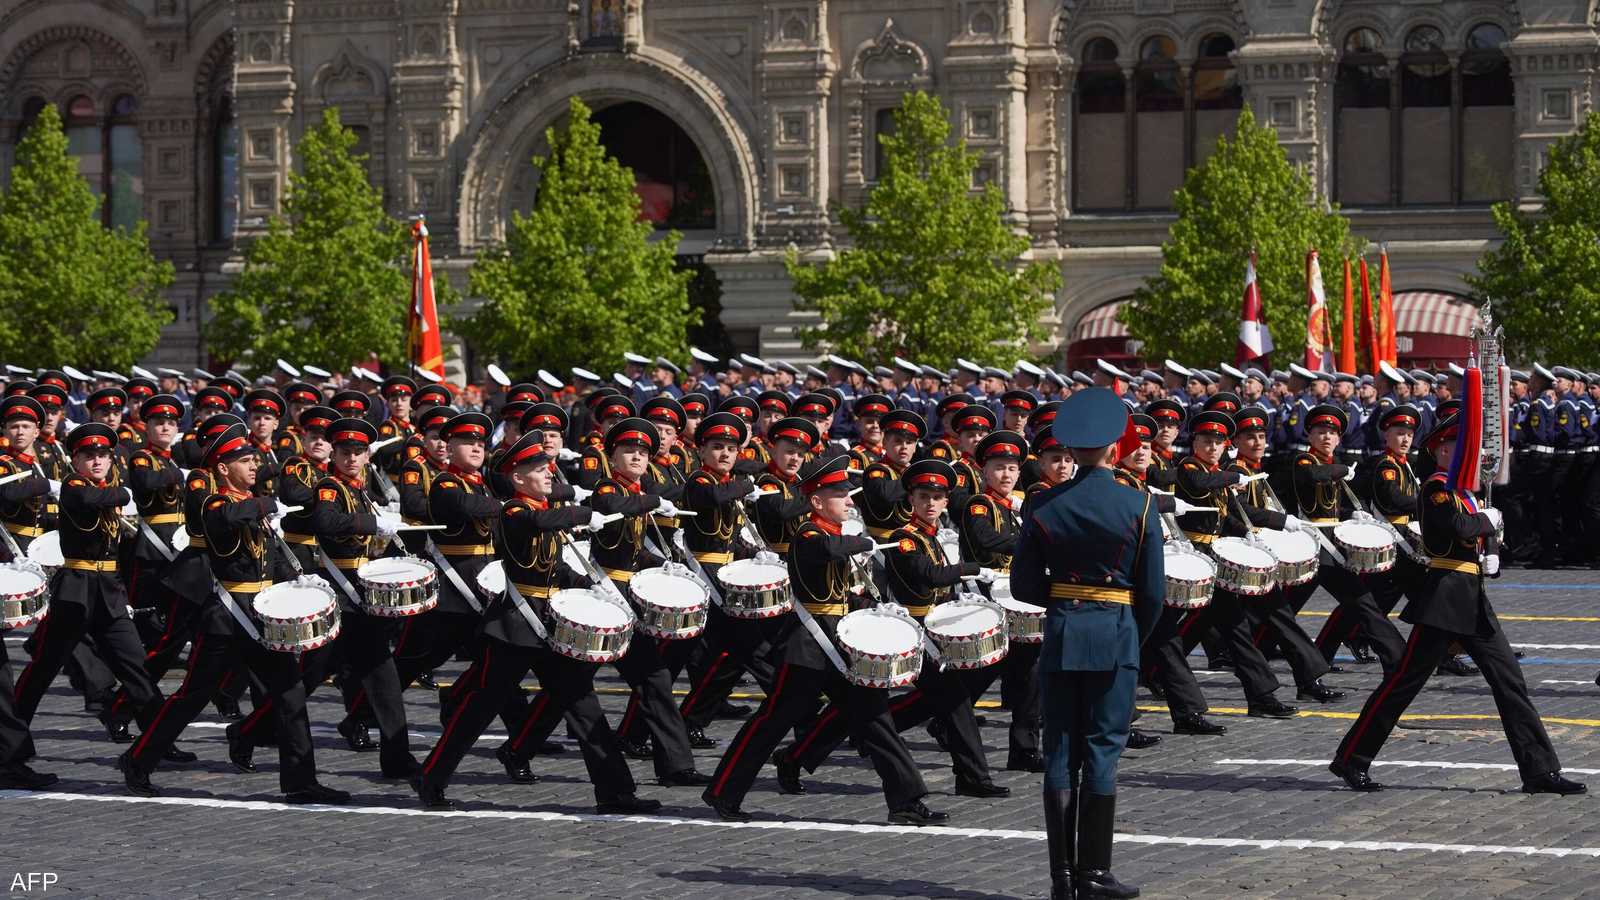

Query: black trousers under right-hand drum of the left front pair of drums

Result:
[235,605,413,773]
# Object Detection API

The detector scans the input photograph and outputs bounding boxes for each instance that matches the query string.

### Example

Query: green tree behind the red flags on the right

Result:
[1118,106,1356,362]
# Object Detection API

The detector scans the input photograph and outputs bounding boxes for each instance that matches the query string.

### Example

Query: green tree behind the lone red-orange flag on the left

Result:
[206,107,432,372]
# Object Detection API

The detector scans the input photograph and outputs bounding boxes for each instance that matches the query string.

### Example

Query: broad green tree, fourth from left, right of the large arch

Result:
[787,91,1061,364]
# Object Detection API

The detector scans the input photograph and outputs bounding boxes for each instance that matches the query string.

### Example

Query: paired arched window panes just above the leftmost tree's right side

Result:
[62,94,144,229]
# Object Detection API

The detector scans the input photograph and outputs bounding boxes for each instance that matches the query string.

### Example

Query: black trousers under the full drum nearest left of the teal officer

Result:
[790,646,1000,781]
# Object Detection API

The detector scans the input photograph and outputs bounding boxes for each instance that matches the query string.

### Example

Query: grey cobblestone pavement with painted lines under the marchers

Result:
[0,570,1600,900]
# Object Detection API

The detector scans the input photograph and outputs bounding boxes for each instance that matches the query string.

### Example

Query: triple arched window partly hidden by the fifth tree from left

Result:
[1072,34,1245,211]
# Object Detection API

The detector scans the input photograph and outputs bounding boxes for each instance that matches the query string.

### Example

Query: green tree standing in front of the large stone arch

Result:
[454,98,699,372]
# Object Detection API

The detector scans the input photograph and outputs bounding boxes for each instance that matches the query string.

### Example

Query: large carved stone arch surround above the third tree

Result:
[458,50,758,250]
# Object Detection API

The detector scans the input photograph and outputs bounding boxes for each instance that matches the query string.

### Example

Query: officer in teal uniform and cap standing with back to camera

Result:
[1011,388,1166,900]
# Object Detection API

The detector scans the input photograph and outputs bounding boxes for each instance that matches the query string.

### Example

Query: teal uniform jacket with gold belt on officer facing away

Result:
[1011,468,1166,673]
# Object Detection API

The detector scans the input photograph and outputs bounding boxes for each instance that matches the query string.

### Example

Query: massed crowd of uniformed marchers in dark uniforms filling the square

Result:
[0,349,1580,897]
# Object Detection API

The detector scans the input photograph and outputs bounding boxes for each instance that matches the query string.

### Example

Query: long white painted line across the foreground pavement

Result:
[0,791,1600,857]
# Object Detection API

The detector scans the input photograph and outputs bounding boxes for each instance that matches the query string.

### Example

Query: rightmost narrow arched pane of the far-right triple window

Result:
[1459,22,1515,203]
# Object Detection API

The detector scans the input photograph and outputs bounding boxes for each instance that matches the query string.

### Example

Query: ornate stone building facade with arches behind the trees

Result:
[0,0,1600,362]
